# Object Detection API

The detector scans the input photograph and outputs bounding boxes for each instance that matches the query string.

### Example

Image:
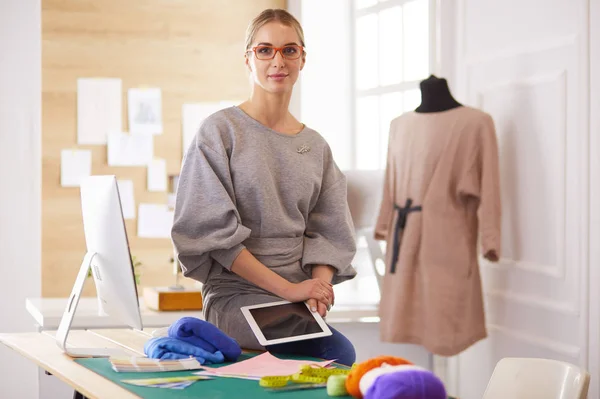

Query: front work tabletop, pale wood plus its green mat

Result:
[0,329,360,399]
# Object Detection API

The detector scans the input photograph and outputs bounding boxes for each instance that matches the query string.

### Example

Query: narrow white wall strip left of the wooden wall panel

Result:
[0,0,41,399]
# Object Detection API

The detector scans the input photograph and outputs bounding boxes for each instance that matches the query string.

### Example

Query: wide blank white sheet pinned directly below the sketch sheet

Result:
[107,132,154,166]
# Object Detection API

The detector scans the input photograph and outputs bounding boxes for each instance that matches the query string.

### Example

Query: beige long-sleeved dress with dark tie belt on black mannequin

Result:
[375,106,501,356]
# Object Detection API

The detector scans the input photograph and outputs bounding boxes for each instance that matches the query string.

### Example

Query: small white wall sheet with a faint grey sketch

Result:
[127,88,163,134]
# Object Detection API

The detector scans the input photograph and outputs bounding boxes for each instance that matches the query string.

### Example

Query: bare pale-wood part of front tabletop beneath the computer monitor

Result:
[0,329,155,399]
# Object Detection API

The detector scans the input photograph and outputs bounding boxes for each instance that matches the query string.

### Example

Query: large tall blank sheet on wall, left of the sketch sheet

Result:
[77,78,123,145]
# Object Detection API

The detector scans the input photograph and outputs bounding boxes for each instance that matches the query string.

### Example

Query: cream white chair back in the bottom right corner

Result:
[483,358,590,399]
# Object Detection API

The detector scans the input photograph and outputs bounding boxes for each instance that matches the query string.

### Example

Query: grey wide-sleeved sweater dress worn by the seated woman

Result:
[171,106,356,349]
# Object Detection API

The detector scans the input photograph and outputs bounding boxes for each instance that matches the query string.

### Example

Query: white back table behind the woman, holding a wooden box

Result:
[25,297,379,331]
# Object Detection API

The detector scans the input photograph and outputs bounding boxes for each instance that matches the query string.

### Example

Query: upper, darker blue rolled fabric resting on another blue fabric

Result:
[168,317,242,361]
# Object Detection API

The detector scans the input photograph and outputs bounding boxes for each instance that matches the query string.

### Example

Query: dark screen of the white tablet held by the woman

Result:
[249,303,323,341]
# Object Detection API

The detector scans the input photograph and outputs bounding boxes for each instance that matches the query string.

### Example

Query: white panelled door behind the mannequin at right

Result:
[441,0,599,399]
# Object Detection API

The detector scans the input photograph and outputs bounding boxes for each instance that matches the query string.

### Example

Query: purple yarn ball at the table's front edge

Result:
[364,370,447,399]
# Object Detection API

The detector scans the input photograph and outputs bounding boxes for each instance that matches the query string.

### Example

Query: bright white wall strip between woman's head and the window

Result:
[288,0,353,169]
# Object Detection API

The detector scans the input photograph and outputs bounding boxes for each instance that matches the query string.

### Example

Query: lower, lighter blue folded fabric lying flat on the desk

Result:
[144,337,225,364]
